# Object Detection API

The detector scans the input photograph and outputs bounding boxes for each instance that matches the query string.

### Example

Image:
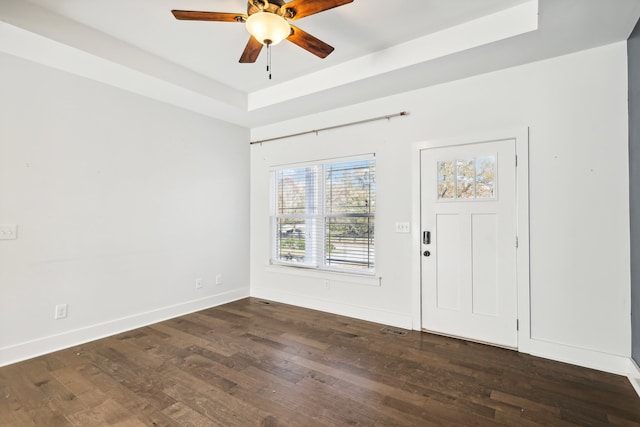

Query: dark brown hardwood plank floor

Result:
[0,298,640,427]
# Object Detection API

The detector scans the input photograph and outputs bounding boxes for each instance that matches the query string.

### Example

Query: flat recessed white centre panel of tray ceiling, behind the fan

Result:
[21,0,525,92]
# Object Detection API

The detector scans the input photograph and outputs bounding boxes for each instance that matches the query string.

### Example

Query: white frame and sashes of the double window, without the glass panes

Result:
[269,154,377,276]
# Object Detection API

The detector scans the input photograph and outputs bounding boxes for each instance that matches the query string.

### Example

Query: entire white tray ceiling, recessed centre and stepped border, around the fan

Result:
[0,0,640,127]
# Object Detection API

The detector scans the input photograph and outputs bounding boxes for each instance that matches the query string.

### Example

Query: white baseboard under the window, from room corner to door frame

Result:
[251,288,412,330]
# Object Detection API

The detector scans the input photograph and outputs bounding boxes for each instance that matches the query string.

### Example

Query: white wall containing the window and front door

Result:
[251,42,630,371]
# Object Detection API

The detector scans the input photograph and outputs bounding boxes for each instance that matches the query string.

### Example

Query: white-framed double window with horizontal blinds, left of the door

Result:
[271,156,376,274]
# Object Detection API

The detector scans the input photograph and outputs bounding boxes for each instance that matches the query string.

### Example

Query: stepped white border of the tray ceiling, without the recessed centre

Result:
[0,0,640,130]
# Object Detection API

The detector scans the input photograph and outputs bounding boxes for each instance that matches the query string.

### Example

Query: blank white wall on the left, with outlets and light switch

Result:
[0,54,249,365]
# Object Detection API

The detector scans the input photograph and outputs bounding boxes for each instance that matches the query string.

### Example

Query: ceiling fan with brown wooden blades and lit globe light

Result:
[171,0,353,63]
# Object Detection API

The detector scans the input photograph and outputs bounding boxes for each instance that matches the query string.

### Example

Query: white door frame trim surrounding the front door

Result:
[411,127,531,353]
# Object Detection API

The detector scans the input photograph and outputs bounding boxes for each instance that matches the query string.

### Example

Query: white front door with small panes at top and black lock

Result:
[420,139,518,348]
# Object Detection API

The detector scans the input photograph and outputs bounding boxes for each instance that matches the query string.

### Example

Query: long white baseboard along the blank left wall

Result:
[0,289,249,366]
